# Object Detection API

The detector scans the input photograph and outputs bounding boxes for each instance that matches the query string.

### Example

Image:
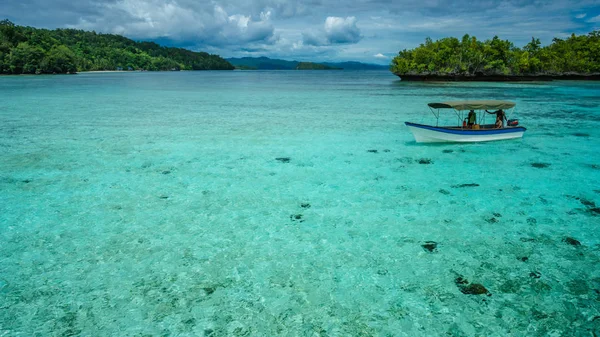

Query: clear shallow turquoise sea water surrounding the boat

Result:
[0,71,600,337]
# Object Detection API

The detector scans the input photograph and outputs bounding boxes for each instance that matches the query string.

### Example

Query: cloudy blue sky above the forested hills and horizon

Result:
[0,0,600,64]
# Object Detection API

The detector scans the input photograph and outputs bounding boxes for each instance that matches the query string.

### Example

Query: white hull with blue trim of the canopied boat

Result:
[405,122,527,143]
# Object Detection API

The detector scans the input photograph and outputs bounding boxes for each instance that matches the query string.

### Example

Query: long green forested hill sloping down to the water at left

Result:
[0,20,234,74]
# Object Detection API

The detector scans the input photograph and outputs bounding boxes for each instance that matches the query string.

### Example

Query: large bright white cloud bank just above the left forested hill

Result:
[71,0,277,46]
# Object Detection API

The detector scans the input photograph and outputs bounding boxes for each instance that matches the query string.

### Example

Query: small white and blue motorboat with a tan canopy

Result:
[405,100,527,143]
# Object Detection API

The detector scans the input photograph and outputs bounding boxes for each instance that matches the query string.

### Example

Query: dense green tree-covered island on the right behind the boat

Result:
[390,31,600,80]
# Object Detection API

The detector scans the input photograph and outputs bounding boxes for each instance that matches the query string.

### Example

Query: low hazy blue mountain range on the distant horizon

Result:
[226,56,389,70]
